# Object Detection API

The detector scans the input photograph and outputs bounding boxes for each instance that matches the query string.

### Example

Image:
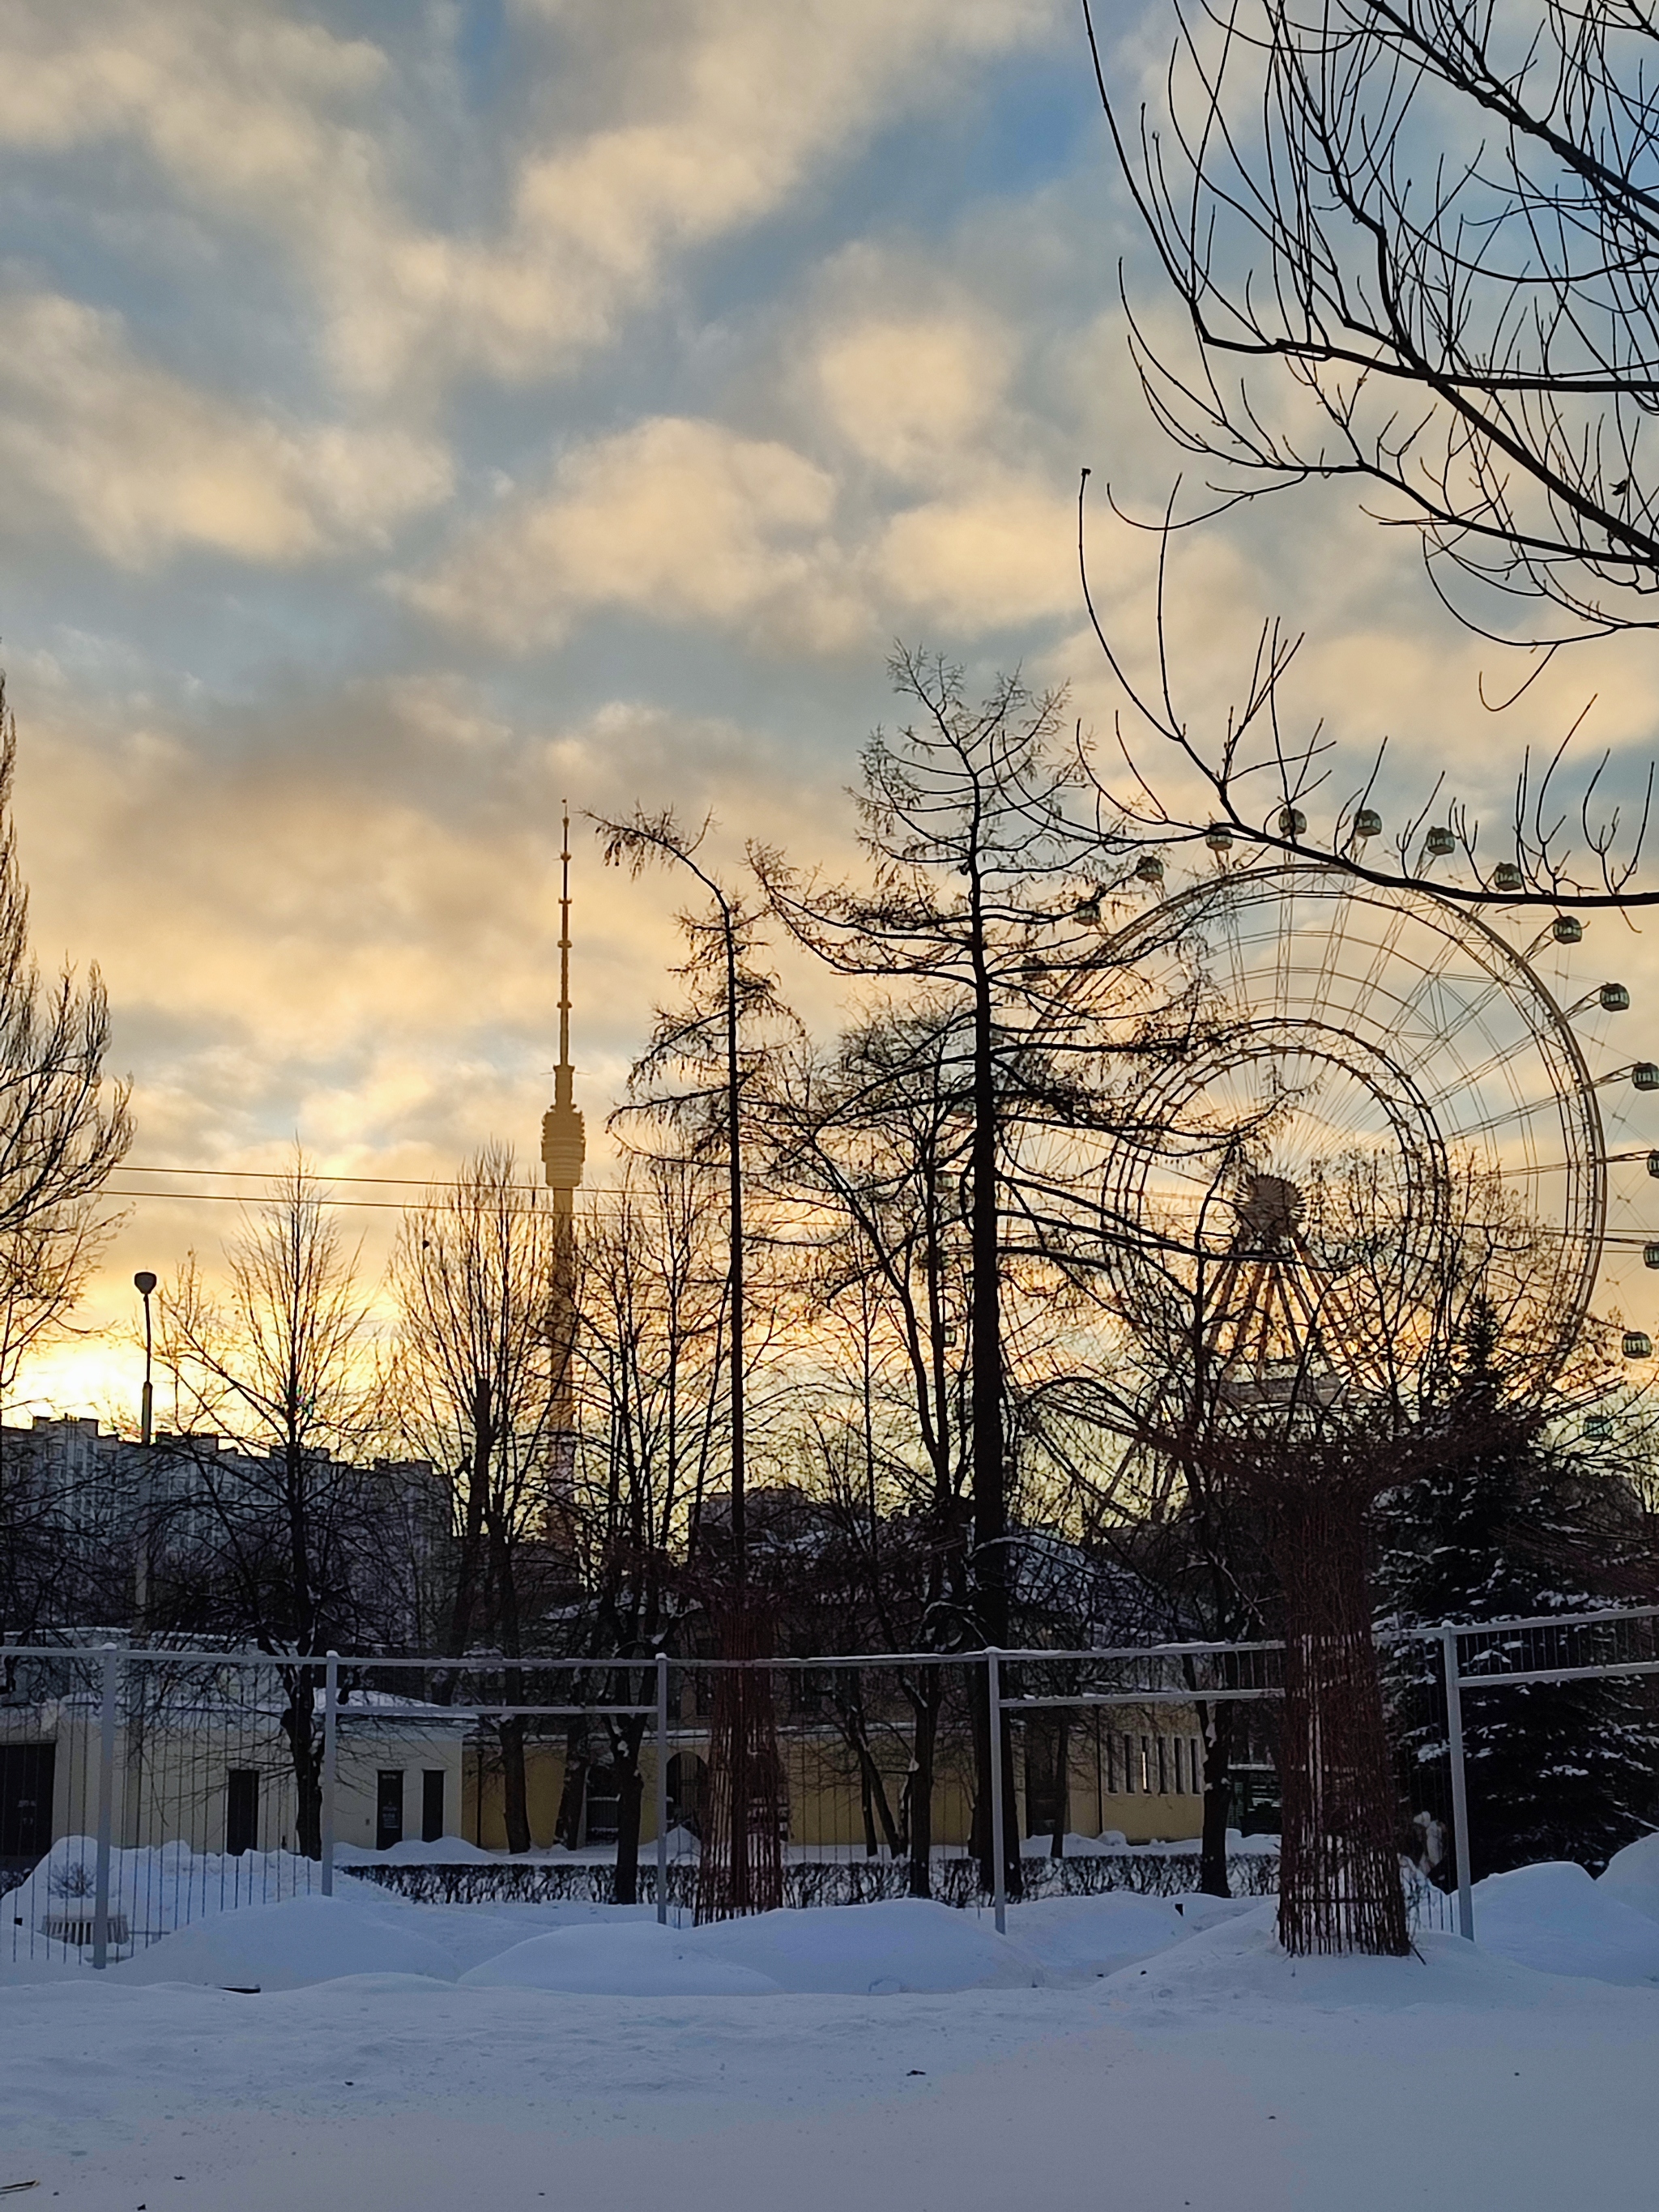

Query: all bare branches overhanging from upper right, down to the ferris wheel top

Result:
[1084,0,1659,907]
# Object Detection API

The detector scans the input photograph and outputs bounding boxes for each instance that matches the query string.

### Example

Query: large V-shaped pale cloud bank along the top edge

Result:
[0,0,1062,391]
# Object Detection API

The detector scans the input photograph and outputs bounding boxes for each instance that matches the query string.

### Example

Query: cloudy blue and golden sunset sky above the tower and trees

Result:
[0,0,1659,1413]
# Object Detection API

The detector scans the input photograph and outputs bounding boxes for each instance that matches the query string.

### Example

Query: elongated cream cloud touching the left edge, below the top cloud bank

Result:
[0,292,449,566]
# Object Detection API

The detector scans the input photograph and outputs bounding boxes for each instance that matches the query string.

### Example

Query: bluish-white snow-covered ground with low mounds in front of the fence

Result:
[0,1845,1659,2212]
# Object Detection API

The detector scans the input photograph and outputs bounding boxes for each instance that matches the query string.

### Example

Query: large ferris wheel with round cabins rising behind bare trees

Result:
[1104,865,1627,1387]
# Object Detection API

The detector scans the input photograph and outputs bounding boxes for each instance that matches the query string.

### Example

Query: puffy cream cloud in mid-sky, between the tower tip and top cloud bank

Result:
[405,416,860,650]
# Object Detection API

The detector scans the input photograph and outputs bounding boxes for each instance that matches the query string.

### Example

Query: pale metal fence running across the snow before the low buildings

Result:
[0,1608,1659,1967]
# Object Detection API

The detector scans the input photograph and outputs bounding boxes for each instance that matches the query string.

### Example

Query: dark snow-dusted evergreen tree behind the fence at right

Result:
[1378,1307,1659,1880]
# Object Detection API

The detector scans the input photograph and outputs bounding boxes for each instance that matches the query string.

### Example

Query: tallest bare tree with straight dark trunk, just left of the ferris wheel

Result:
[754,650,1158,1885]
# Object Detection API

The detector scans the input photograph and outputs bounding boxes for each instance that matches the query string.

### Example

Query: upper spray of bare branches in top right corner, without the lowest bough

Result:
[1090,0,1659,637]
